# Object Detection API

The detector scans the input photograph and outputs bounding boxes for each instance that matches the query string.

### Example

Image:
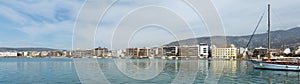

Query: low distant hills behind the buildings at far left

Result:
[0,47,58,51]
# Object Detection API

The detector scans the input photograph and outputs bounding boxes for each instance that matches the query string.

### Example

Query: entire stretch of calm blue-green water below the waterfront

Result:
[0,58,300,84]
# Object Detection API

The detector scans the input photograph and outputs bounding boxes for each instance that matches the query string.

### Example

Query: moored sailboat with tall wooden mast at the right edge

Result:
[250,4,300,71]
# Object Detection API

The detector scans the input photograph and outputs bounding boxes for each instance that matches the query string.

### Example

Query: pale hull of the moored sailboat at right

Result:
[251,61,300,71]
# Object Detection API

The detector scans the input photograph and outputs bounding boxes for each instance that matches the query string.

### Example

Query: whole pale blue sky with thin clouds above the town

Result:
[0,0,300,49]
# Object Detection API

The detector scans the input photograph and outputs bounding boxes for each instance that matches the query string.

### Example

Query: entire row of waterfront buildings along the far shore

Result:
[0,43,258,59]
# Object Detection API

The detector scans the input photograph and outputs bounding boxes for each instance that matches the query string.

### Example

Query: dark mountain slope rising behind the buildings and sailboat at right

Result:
[165,27,300,50]
